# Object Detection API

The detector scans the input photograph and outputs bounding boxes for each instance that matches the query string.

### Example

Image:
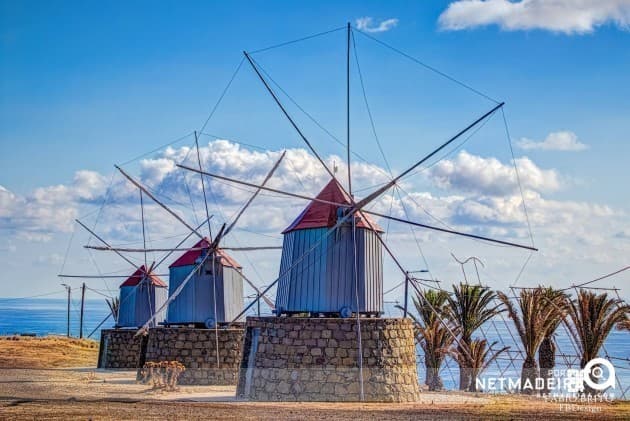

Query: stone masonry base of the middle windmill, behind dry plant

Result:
[146,327,245,385]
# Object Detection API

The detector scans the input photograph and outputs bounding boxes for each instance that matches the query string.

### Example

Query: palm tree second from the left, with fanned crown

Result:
[445,283,504,390]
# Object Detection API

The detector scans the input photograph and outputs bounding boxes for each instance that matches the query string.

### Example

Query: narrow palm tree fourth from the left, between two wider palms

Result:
[538,287,569,394]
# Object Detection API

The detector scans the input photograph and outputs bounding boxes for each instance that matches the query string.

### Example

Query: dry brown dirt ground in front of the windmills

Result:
[0,338,630,421]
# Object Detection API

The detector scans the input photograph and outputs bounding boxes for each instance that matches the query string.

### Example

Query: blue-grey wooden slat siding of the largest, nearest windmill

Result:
[276,226,383,313]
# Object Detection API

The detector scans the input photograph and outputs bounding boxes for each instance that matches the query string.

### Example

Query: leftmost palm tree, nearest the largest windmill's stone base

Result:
[411,290,457,391]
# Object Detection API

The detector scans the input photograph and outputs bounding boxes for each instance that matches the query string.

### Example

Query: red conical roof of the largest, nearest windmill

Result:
[282,178,383,234]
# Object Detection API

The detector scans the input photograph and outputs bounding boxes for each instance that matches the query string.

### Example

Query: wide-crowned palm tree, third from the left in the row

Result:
[498,287,562,394]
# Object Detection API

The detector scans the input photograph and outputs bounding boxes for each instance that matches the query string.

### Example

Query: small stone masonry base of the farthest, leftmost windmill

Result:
[98,329,147,369]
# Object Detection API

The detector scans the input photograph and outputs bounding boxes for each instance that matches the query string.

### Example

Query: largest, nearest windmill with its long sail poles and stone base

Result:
[178,24,537,401]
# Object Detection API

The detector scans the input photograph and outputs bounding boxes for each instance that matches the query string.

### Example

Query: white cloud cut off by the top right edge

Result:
[439,0,630,34]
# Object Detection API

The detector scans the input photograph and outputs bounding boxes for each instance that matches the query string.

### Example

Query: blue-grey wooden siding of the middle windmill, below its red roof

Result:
[166,263,243,324]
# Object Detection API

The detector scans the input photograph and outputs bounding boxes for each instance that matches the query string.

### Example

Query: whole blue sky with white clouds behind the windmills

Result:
[0,0,630,300]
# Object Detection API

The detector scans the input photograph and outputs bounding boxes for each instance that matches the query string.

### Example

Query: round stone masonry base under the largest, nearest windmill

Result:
[237,317,419,402]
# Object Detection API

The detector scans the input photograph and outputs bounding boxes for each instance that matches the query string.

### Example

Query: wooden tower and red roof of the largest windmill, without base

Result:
[276,179,383,317]
